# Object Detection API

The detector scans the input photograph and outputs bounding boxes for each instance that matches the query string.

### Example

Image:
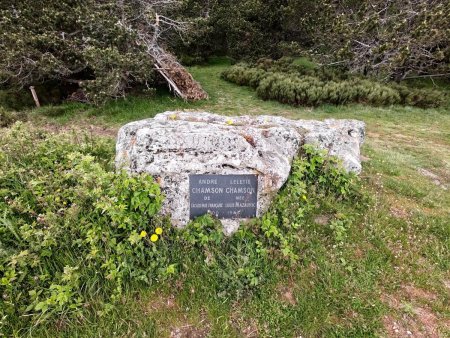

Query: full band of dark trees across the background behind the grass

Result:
[0,0,450,102]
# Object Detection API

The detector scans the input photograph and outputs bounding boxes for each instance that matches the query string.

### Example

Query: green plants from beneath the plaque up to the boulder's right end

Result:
[181,145,361,297]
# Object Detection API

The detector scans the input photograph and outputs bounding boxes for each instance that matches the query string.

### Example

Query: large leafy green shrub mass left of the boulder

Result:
[0,124,170,332]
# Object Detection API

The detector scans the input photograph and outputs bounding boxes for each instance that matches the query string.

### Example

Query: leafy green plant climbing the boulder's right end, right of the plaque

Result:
[250,145,362,262]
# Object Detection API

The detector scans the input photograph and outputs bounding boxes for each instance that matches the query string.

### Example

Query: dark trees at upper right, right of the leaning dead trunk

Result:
[181,0,450,80]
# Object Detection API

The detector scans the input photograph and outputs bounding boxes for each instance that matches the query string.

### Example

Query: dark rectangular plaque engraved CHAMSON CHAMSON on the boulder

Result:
[189,175,258,219]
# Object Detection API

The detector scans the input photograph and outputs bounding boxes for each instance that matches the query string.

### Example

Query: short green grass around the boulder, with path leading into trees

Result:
[3,62,450,337]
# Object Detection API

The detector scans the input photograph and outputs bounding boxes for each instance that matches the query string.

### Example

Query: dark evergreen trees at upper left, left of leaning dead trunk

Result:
[0,0,185,102]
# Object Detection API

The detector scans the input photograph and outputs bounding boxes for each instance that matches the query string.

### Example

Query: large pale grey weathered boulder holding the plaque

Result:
[116,112,365,232]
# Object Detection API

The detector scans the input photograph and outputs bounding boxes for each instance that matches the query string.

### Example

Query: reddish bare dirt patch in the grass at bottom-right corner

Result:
[381,285,449,338]
